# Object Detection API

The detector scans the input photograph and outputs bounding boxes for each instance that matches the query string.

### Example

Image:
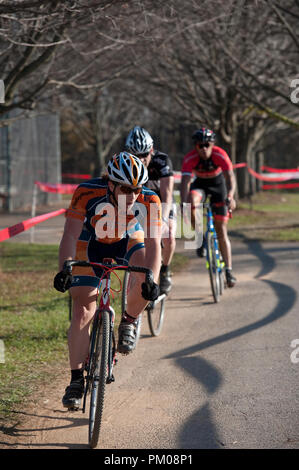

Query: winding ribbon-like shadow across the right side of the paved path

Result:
[169,236,299,449]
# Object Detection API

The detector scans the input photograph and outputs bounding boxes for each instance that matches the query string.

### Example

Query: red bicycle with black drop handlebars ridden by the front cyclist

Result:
[63,259,154,449]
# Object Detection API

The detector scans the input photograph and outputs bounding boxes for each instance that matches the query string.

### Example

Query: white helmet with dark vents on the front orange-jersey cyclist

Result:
[107,152,148,186]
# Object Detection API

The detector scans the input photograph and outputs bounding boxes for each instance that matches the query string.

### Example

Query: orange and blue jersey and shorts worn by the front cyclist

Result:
[66,178,162,286]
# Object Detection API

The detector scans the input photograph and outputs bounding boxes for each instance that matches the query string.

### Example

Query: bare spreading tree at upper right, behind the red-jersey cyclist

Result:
[119,0,295,196]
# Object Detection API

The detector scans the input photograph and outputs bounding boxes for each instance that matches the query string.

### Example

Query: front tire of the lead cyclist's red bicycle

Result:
[88,310,110,449]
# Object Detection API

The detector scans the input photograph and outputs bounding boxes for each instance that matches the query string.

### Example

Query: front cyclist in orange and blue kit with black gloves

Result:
[54,152,162,408]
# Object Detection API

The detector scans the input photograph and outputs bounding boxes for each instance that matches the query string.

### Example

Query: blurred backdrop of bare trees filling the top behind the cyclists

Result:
[0,0,299,197]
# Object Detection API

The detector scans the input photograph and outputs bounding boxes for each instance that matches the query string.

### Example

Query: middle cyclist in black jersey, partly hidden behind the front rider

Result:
[125,126,176,294]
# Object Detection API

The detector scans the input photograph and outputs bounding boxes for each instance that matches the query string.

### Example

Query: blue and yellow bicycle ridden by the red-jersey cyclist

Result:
[203,201,225,303]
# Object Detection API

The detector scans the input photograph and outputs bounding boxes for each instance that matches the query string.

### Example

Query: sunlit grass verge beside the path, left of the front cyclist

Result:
[0,243,186,428]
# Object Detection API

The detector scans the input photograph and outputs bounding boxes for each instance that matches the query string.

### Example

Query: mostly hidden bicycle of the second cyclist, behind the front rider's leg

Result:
[122,271,167,345]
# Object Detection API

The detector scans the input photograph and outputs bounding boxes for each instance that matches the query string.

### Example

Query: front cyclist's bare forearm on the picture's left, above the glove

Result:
[59,218,83,271]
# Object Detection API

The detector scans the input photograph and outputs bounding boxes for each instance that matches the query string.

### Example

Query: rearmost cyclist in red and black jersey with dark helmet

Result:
[181,127,237,287]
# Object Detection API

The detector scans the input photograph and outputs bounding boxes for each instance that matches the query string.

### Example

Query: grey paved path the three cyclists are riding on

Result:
[0,218,299,449]
